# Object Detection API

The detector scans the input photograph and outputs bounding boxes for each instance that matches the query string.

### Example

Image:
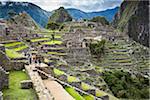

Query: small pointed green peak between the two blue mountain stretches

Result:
[49,7,72,23]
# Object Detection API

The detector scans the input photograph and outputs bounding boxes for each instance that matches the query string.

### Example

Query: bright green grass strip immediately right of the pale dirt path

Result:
[65,87,85,100]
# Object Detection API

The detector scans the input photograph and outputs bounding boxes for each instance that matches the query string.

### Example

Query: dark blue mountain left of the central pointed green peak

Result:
[0,2,51,27]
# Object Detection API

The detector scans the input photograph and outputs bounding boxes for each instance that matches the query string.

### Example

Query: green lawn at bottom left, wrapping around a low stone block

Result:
[3,71,36,100]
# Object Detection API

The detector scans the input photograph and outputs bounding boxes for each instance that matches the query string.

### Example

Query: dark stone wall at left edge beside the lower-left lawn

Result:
[0,67,9,91]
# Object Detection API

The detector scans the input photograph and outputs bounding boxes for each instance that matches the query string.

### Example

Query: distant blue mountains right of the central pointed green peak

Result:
[67,7,119,22]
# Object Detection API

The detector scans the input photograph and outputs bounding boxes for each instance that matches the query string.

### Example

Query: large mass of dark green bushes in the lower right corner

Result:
[103,70,150,99]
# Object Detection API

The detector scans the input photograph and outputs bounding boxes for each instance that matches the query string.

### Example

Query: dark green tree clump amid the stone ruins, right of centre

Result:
[89,40,106,56]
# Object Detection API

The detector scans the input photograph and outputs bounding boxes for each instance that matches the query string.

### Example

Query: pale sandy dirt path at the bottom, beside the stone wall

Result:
[44,80,75,100]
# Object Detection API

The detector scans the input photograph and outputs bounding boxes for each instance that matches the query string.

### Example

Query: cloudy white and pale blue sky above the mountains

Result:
[0,0,123,12]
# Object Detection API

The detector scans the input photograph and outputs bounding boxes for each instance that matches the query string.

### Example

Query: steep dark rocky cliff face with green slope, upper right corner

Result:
[113,0,149,47]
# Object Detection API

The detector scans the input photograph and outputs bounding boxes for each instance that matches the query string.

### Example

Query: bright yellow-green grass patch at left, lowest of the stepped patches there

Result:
[6,49,24,58]
